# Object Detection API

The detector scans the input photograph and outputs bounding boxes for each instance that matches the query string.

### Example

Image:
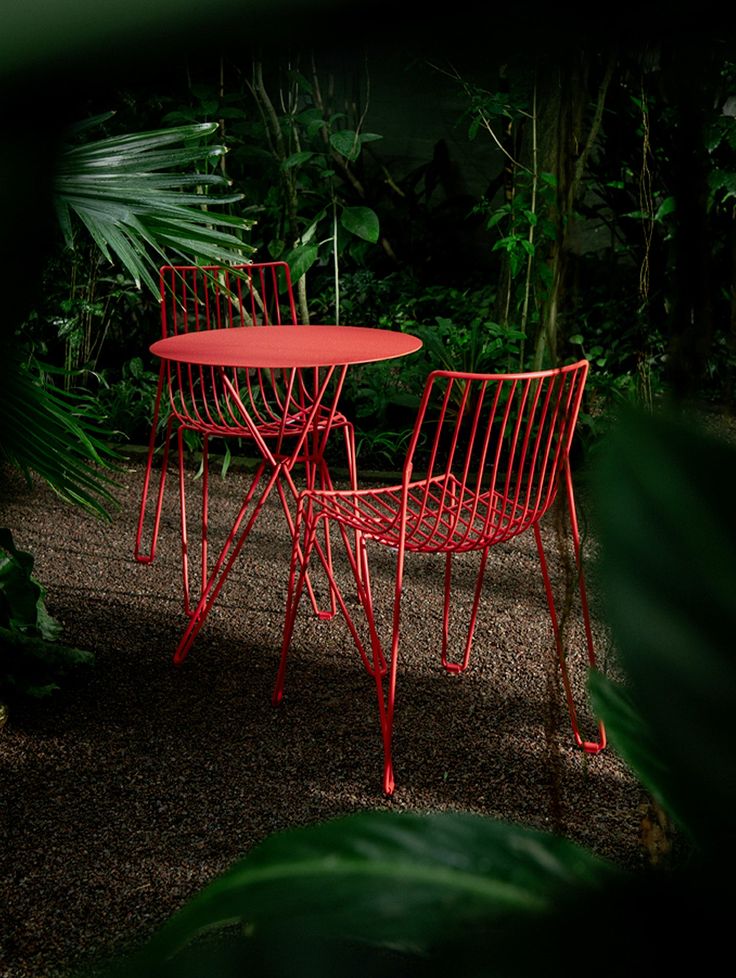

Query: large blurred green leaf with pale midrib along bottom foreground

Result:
[118,812,618,976]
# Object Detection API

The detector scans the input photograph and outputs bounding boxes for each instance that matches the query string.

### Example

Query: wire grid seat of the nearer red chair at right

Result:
[303,475,548,553]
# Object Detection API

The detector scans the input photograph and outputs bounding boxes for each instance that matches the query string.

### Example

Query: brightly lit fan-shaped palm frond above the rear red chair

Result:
[54,117,253,294]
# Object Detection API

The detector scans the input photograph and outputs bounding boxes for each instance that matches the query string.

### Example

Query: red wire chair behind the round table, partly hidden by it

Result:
[135,262,357,618]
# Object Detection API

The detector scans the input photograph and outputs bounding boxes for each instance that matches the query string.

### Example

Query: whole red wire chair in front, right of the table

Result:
[273,360,606,795]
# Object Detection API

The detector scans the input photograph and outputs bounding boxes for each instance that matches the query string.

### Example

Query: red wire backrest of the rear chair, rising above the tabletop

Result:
[159,262,297,336]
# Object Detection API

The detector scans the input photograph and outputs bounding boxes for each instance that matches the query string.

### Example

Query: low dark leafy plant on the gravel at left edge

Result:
[0,528,94,699]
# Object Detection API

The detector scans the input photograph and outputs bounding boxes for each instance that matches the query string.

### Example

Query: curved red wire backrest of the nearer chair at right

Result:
[403,360,588,550]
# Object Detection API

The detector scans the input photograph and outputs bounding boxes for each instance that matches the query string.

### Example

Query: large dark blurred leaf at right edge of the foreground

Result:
[597,413,736,853]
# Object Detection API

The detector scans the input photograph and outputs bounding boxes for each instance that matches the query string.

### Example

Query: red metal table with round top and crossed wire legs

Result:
[150,324,422,665]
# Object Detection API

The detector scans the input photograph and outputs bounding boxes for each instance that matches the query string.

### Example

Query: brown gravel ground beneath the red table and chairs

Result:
[0,462,651,978]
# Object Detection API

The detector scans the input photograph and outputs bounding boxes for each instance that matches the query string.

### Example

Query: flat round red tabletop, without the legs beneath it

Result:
[151,325,422,368]
